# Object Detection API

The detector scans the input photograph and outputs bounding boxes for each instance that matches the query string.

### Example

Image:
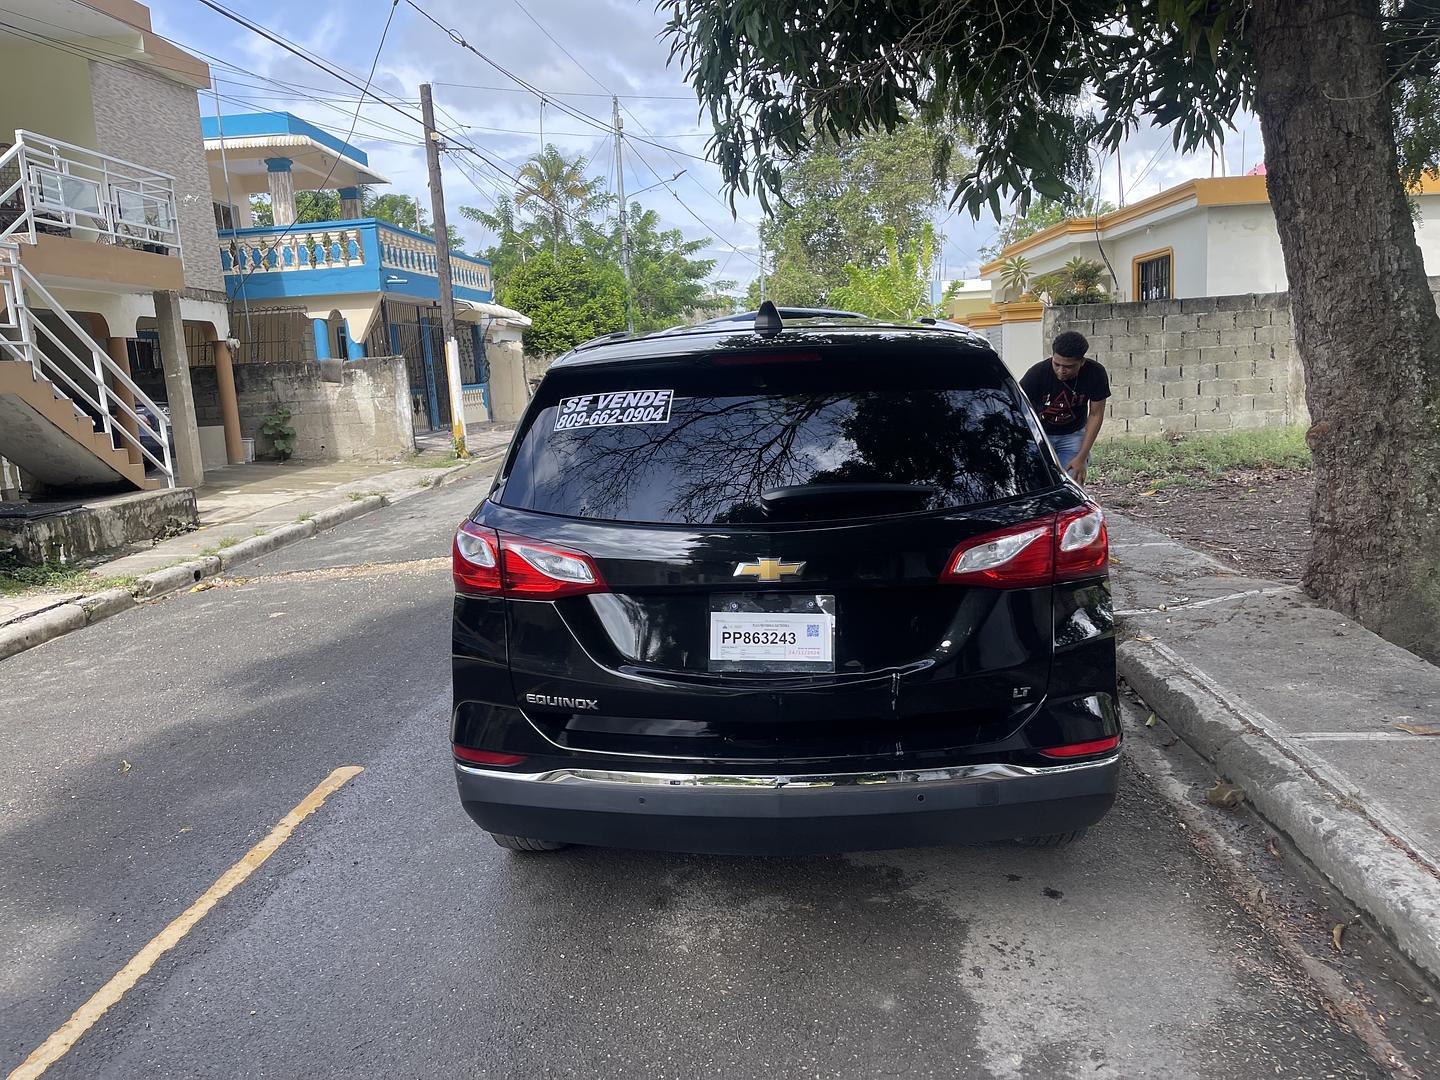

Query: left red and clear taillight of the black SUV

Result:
[451,521,605,600]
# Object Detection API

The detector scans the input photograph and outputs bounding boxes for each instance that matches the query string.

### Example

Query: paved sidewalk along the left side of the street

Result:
[0,423,514,642]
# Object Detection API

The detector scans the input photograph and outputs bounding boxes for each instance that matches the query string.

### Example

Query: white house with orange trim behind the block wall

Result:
[962,170,1440,380]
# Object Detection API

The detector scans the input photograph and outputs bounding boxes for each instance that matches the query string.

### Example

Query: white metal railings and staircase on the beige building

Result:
[0,132,174,488]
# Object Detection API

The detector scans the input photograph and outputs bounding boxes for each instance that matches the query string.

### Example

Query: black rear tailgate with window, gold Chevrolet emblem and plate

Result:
[478,336,1073,760]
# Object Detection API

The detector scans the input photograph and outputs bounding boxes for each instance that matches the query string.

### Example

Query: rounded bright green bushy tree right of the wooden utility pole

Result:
[498,248,625,356]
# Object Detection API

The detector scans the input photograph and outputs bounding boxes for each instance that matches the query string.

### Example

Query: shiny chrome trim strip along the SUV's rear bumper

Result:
[455,750,1120,791]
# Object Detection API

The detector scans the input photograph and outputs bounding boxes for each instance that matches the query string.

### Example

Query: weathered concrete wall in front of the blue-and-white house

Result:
[226,356,415,461]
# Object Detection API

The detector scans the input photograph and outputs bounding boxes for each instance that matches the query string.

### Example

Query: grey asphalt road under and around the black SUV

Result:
[0,482,1434,1080]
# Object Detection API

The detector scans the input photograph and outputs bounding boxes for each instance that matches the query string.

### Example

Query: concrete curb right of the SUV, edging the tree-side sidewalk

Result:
[1117,639,1440,979]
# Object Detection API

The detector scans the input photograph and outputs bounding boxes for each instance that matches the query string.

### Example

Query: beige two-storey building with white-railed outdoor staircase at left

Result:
[0,0,242,494]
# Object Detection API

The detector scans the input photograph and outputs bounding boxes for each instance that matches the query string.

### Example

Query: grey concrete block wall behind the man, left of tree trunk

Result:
[1044,292,1309,438]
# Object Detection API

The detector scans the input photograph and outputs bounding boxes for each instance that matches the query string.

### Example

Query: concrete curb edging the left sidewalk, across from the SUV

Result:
[0,495,394,660]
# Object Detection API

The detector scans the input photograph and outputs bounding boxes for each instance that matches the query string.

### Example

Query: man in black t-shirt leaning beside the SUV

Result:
[1020,330,1110,484]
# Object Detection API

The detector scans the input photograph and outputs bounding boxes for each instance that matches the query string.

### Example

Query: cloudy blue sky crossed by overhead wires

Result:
[148,0,1260,287]
